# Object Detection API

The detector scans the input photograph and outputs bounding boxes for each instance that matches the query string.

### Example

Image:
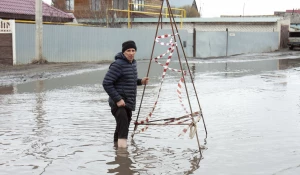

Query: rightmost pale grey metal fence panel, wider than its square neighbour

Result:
[228,32,279,55]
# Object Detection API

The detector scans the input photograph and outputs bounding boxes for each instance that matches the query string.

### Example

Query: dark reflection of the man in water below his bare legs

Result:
[106,148,138,175]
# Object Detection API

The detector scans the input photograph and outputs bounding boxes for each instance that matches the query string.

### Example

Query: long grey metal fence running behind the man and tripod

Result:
[16,23,279,64]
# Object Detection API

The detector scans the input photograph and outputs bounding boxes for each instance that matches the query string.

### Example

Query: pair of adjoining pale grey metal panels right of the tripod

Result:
[197,32,279,58]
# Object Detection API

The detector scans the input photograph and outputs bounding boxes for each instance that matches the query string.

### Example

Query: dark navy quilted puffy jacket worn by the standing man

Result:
[102,52,142,111]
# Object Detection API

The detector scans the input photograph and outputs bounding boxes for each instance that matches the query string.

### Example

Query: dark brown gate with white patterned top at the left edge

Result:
[0,19,16,65]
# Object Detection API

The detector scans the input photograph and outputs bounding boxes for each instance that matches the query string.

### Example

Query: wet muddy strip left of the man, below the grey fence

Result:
[0,62,109,86]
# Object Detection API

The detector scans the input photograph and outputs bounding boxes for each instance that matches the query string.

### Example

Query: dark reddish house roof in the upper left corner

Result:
[0,0,74,23]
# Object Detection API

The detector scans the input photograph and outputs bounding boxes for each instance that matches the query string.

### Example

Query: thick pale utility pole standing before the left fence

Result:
[35,0,43,63]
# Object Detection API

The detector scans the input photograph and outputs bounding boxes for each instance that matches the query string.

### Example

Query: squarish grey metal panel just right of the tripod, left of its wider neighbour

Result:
[196,32,226,58]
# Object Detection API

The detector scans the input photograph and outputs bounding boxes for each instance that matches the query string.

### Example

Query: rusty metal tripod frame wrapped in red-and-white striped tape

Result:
[132,0,207,157]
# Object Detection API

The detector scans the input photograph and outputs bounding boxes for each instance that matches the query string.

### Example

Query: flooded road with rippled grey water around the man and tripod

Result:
[0,56,300,175]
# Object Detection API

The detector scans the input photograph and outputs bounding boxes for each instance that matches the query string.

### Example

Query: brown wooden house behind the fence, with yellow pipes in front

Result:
[53,0,198,24]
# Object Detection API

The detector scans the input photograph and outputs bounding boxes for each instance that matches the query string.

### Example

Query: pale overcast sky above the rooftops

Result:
[43,0,300,17]
